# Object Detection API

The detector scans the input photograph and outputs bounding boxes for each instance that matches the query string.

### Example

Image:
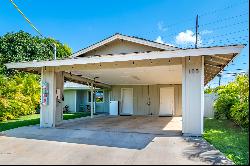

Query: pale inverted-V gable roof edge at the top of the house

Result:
[72,33,180,57]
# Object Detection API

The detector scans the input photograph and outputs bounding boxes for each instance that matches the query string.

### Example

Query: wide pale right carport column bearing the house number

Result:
[182,56,204,136]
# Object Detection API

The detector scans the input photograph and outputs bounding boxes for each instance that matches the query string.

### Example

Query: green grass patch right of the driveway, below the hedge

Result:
[203,119,249,165]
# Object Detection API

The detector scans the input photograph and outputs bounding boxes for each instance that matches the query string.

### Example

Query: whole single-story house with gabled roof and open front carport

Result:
[6,34,245,135]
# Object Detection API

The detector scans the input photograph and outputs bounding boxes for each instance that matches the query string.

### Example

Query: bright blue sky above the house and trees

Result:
[0,0,249,86]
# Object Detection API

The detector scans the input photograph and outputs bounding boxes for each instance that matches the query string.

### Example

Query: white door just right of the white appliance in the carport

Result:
[121,88,133,115]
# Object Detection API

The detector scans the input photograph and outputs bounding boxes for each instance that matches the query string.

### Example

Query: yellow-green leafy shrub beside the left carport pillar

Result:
[0,73,40,121]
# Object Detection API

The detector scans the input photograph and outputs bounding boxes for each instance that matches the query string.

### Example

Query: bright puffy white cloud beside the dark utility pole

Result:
[175,30,202,46]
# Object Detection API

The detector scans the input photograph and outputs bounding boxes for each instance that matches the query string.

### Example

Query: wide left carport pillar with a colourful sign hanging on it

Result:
[40,67,64,127]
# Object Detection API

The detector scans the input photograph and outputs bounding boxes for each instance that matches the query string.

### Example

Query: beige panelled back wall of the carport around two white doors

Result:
[110,84,182,116]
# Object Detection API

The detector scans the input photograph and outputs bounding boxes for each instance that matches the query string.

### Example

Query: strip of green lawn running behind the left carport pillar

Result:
[0,112,90,132]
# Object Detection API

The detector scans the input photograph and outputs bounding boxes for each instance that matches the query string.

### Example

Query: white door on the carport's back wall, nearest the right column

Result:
[159,87,174,116]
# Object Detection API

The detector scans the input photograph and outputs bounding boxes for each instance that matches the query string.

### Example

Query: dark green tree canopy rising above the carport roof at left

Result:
[0,31,72,74]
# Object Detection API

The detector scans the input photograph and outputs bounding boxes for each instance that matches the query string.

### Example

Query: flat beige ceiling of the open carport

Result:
[72,65,182,85]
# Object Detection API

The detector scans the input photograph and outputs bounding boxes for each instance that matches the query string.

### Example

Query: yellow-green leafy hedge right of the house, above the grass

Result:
[214,75,249,128]
